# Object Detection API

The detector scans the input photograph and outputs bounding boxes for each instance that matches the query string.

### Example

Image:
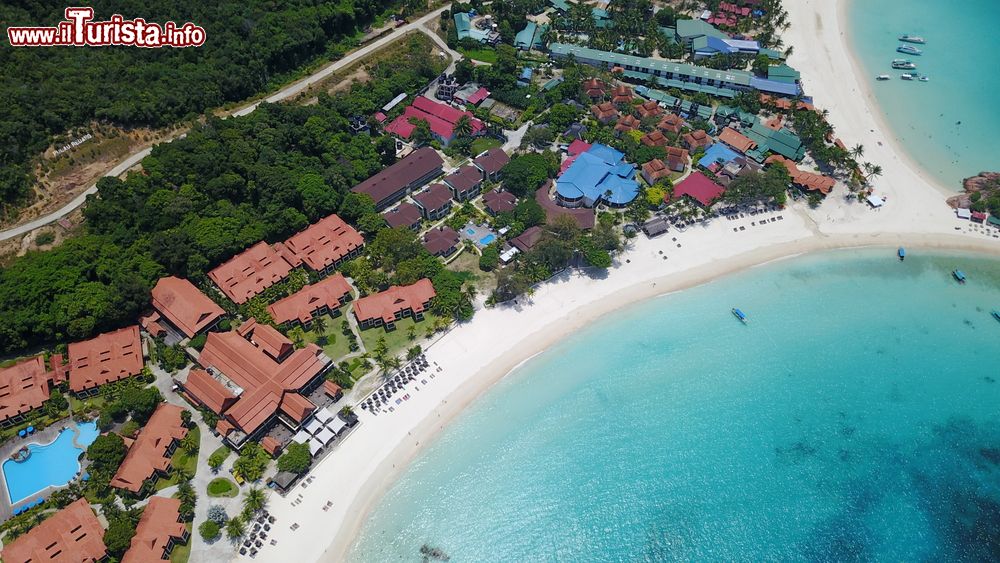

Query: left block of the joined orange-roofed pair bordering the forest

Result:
[208,241,297,305]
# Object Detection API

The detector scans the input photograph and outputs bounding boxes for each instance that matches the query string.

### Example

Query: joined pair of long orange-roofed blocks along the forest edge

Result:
[208,215,364,305]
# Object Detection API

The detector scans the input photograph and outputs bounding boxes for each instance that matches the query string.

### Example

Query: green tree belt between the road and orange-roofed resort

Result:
[0,36,440,360]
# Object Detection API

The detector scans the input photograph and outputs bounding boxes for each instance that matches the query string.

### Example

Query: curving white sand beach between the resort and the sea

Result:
[244,0,1000,563]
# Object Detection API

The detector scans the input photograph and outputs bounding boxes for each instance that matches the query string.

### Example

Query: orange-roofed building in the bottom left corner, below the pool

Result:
[0,498,108,563]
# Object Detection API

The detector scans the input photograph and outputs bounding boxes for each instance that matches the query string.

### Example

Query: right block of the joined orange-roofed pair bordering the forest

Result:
[285,215,365,276]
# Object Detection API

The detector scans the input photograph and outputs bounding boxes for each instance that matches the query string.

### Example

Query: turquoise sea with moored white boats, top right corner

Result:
[848,0,1000,191]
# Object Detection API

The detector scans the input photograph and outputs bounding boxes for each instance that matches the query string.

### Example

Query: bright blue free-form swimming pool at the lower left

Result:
[3,422,100,504]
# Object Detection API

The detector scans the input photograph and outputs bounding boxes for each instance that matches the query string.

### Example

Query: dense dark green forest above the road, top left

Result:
[0,0,394,214]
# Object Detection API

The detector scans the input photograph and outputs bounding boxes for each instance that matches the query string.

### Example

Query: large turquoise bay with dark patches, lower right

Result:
[349,249,1000,562]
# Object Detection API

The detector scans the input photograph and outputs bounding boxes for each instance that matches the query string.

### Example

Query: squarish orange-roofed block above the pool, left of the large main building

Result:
[68,325,144,395]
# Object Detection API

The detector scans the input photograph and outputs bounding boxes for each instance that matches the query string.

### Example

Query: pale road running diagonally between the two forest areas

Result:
[0,4,461,241]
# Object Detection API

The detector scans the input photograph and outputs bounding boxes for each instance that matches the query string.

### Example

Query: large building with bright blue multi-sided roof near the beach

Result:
[556,143,639,207]
